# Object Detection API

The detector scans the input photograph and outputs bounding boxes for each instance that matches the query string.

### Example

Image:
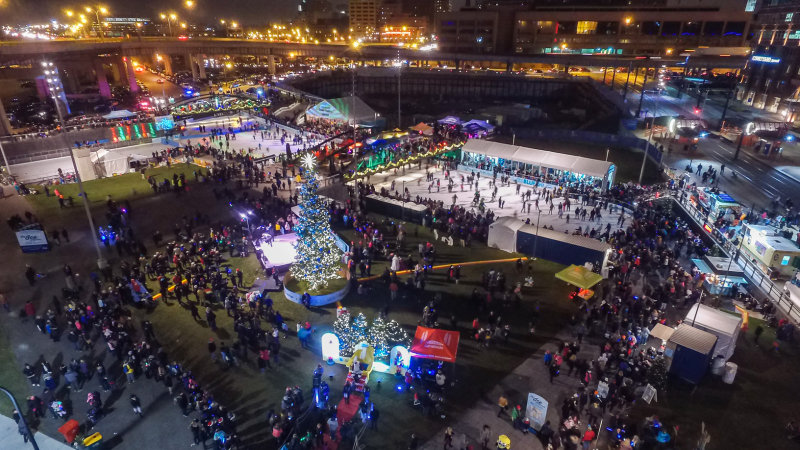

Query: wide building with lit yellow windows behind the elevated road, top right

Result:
[435,0,752,56]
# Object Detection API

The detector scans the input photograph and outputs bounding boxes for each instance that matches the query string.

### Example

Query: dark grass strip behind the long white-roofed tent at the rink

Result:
[496,136,664,184]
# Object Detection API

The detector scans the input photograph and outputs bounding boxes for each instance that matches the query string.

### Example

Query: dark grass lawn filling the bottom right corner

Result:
[634,319,800,449]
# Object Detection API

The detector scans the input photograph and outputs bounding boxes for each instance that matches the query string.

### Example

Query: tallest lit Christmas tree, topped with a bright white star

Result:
[292,154,341,289]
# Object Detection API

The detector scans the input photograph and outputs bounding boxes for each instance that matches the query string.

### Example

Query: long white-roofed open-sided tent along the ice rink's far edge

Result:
[459,139,616,192]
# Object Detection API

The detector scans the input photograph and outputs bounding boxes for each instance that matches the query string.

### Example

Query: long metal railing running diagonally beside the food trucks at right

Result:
[671,190,800,323]
